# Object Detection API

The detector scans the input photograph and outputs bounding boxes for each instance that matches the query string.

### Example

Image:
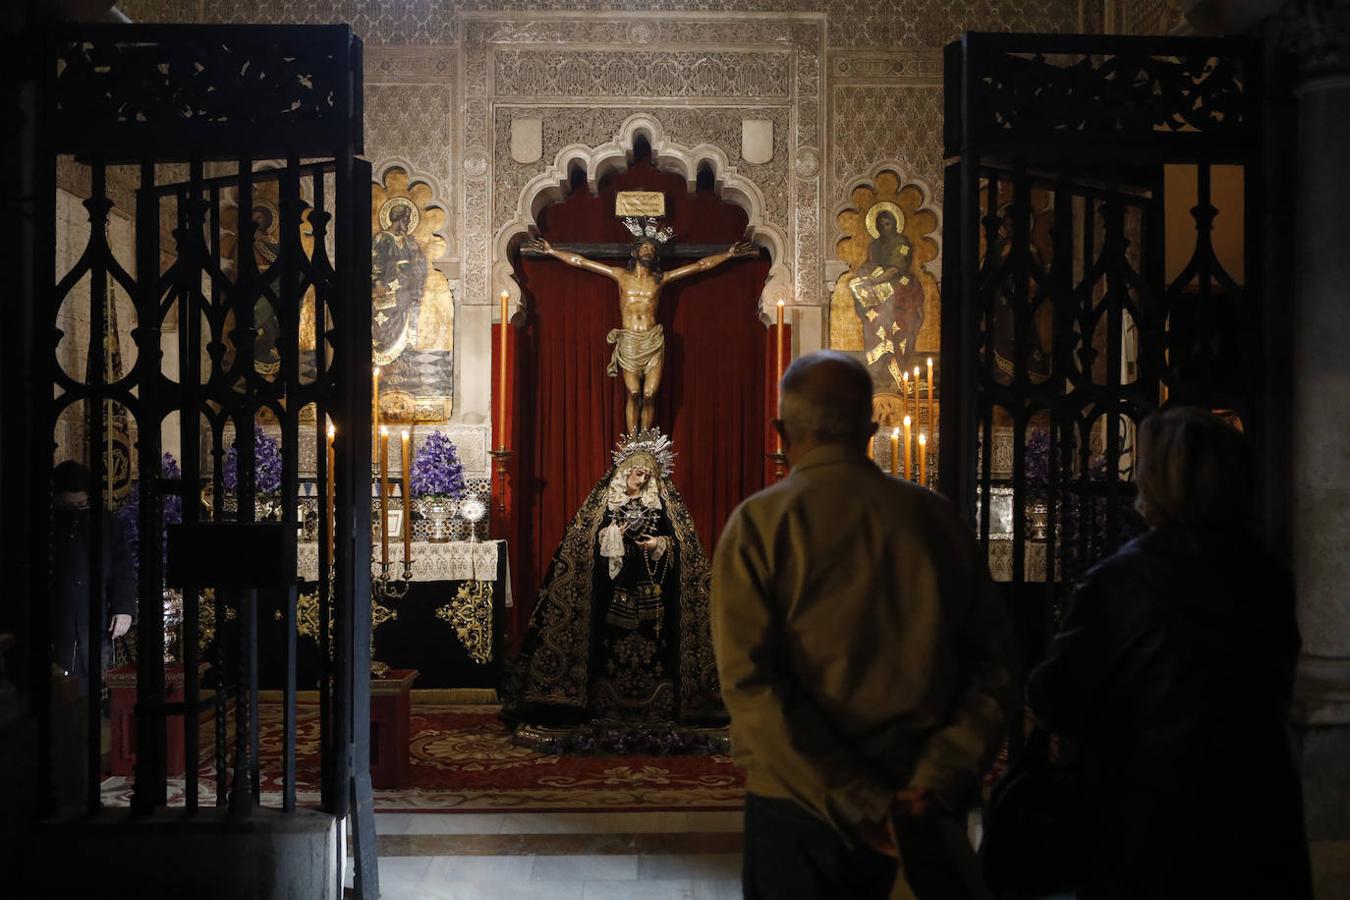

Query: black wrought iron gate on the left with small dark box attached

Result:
[30,26,378,896]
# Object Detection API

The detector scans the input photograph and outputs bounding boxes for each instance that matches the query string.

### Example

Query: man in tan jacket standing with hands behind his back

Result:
[711,351,1021,900]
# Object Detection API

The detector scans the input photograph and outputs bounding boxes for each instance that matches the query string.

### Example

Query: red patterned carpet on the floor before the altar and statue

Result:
[103,704,744,812]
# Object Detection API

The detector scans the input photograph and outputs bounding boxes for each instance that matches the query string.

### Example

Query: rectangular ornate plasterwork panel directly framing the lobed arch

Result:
[460,13,826,313]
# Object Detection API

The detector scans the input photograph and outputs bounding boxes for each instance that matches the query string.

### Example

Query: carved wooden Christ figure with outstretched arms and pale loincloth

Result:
[524,237,759,434]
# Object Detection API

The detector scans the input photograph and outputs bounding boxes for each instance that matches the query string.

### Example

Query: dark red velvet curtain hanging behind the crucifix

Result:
[510,159,772,638]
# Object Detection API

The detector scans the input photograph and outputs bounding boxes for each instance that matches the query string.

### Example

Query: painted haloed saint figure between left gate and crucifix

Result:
[370,197,427,366]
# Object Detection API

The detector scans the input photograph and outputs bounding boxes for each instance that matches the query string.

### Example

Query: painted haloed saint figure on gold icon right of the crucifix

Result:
[849,202,923,386]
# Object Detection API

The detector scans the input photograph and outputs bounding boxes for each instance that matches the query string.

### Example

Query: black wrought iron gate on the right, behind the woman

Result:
[941,34,1264,663]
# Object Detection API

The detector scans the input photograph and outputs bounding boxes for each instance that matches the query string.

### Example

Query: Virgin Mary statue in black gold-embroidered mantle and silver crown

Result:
[502,428,726,750]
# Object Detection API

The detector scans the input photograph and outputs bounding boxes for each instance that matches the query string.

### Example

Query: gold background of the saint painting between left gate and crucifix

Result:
[370,166,455,424]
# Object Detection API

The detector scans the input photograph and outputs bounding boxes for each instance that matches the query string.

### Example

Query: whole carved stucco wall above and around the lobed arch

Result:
[120,0,1107,422]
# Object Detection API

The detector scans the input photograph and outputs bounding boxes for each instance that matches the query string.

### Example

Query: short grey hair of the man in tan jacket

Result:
[779,349,872,441]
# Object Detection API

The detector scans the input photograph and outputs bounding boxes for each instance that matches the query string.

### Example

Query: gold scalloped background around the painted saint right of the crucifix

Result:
[830,171,942,354]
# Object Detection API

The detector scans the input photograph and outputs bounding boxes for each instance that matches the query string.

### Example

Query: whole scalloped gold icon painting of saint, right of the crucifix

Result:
[830,170,940,394]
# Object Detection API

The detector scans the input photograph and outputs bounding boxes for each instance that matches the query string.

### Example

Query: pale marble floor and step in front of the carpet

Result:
[348,811,741,900]
